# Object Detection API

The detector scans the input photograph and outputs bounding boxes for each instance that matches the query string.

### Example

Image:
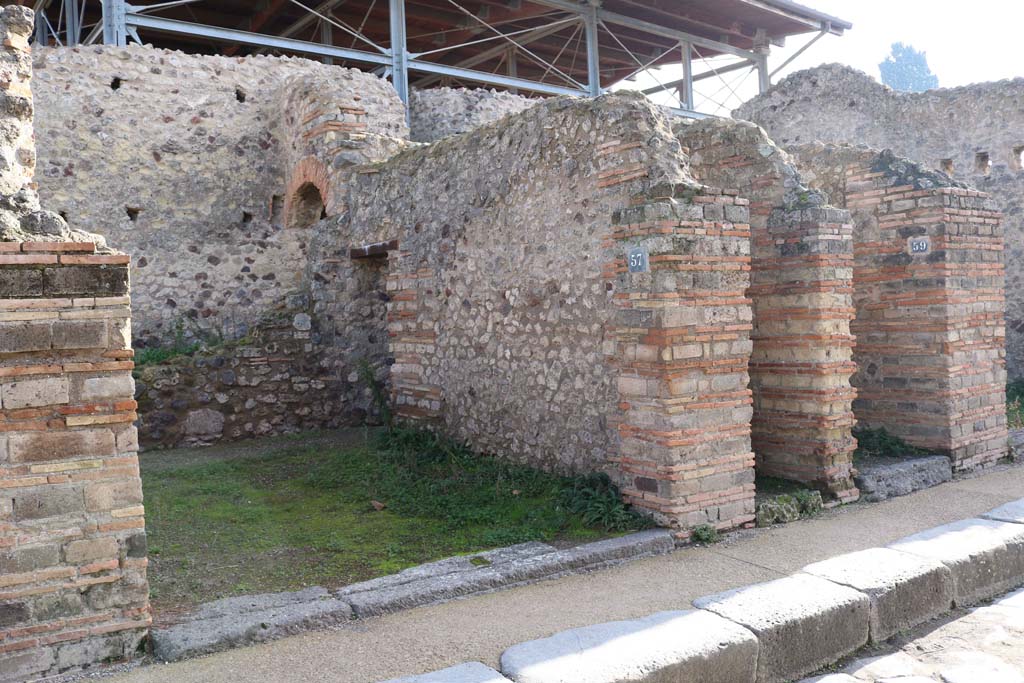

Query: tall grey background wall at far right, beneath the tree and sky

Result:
[734,65,1024,378]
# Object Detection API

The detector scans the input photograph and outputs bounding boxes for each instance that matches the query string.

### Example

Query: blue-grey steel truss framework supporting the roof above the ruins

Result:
[34,0,829,117]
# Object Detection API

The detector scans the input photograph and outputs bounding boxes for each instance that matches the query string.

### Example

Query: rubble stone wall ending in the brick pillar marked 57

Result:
[310,95,753,535]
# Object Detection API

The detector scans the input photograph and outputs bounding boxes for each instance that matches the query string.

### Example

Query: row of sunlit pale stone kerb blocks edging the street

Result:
[392,499,1024,683]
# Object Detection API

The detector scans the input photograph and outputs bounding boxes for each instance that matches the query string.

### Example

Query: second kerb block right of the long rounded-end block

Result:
[804,548,953,642]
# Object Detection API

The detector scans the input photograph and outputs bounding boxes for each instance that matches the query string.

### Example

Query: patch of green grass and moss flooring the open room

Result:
[141,430,646,620]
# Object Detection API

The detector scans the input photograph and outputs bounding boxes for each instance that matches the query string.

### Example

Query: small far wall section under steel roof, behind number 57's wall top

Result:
[409,88,543,142]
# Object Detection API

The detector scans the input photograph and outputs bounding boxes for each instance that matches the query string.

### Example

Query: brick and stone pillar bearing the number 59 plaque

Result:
[846,163,1007,470]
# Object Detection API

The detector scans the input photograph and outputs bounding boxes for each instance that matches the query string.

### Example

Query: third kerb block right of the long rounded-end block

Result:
[889,518,1024,606]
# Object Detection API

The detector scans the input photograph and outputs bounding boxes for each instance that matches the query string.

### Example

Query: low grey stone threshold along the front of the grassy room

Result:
[144,529,675,659]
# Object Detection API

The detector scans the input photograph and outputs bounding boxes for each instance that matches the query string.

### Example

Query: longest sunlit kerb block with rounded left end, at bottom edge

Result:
[501,610,758,683]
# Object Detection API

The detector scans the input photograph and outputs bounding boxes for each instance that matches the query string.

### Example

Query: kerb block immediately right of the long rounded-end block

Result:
[693,574,870,683]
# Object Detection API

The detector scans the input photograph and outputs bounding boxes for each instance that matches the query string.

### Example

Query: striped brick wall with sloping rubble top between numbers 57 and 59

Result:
[676,119,857,501]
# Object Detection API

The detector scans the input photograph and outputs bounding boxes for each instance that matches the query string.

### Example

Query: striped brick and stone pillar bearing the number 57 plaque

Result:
[605,185,754,538]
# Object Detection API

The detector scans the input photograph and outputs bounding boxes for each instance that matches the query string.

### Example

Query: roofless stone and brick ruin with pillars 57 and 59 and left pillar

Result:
[0,7,1007,675]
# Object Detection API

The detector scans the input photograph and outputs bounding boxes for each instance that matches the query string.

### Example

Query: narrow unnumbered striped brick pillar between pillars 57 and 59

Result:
[750,207,858,502]
